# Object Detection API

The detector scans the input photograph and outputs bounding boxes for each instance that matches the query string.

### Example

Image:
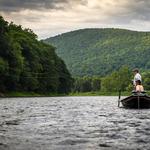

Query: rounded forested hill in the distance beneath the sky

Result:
[45,29,150,76]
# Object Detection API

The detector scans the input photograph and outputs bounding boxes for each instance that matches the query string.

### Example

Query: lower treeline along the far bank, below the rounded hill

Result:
[72,66,150,92]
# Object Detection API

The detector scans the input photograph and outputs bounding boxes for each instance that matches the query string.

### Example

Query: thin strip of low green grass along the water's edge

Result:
[0,91,150,98]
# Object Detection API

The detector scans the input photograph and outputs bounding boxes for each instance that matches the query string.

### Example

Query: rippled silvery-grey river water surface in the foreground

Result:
[0,97,150,150]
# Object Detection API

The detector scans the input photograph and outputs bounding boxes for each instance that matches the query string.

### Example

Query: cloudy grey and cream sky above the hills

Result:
[0,0,150,39]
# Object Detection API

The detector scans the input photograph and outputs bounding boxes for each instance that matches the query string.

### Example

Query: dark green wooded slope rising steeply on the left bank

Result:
[0,17,73,93]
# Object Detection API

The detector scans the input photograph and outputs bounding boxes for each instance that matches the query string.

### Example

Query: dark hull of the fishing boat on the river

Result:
[121,95,150,109]
